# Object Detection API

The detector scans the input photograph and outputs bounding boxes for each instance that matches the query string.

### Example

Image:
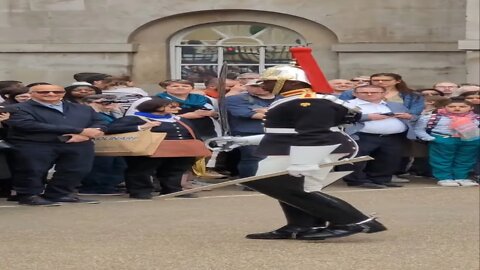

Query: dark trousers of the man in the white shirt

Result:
[338,133,406,185]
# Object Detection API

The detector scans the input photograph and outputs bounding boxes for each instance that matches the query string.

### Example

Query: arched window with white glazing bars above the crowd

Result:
[171,23,306,83]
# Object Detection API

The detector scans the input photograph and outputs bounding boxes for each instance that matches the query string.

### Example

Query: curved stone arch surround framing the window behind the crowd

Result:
[129,10,338,89]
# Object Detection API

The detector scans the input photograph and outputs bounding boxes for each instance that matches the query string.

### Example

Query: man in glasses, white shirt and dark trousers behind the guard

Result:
[339,85,415,188]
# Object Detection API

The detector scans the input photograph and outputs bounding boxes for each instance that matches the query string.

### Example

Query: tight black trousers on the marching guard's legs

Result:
[243,175,368,227]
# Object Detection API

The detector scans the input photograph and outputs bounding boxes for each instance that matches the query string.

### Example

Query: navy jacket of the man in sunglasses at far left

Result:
[6,100,106,142]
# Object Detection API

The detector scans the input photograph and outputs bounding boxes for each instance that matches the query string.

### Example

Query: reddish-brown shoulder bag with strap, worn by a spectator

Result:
[151,121,212,157]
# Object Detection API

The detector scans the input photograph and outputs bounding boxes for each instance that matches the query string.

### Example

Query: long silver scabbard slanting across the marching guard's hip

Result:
[157,156,373,199]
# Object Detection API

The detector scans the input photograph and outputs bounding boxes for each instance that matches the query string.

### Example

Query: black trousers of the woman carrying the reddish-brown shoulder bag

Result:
[125,156,195,194]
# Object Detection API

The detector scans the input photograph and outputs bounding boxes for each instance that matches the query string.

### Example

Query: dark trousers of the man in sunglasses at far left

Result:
[11,141,94,198]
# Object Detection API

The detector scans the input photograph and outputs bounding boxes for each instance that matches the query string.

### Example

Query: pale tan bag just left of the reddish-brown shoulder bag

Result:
[94,130,167,156]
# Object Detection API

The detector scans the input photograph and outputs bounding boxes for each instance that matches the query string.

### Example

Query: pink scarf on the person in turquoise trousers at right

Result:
[438,109,480,141]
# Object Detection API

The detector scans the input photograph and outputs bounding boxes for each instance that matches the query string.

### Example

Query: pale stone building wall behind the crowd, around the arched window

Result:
[0,0,478,86]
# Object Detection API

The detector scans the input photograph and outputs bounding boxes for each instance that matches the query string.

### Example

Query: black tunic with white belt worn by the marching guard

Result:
[257,96,354,156]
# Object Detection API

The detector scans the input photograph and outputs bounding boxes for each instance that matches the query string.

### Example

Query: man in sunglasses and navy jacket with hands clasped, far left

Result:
[7,85,106,205]
